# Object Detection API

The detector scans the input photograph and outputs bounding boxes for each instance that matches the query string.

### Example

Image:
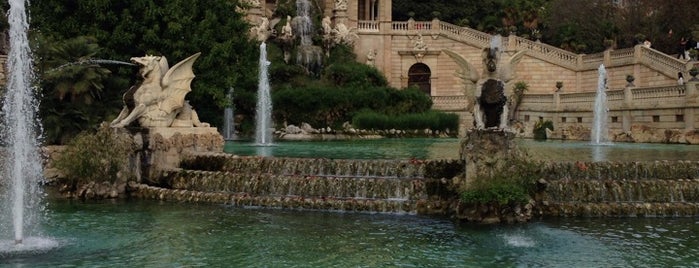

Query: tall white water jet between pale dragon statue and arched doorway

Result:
[255,42,272,145]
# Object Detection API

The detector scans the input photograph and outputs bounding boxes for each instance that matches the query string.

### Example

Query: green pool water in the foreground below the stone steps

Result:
[0,200,699,267]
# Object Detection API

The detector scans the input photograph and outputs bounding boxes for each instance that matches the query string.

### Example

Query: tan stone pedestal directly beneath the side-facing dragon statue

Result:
[127,127,224,184]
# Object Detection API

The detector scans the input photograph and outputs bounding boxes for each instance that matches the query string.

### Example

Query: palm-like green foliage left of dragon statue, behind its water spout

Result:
[35,36,128,144]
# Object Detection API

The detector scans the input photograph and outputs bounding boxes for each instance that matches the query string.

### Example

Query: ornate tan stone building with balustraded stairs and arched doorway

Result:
[243,0,699,144]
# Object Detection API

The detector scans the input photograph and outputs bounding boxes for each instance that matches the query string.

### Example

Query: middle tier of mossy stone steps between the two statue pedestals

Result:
[159,170,443,200]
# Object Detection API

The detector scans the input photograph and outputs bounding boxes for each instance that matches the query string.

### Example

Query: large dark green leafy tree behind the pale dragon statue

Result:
[30,0,259,140]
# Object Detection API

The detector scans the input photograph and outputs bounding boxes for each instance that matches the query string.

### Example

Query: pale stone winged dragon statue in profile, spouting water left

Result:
[110,52,209,128]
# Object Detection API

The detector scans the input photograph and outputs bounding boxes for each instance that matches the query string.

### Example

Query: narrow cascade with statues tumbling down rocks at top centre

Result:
[292,0,323,74]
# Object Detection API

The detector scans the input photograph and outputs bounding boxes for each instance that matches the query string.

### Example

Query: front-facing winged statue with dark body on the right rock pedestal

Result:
[444,39,524,129]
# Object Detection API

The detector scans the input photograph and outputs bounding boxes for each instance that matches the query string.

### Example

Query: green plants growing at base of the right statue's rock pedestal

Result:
[461,157,543,205]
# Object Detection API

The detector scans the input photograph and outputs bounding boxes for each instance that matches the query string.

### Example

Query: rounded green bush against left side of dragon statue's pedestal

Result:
[54,126,133,190]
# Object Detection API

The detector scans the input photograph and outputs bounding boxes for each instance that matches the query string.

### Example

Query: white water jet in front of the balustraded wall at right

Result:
[590,64,608,145]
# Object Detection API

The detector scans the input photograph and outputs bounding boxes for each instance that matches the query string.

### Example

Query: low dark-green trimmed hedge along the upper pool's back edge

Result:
[352,110,459,131]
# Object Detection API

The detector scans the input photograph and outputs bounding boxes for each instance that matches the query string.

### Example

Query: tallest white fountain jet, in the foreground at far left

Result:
[0,0,57,253]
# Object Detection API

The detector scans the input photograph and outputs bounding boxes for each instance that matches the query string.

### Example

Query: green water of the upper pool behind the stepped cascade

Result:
[224,138,699,161]
